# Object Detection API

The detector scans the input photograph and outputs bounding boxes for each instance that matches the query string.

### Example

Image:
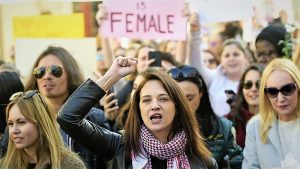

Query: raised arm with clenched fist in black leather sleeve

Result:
[57,57,137,160]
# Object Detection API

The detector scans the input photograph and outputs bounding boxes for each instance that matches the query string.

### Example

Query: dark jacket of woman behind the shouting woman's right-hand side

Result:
[205,117,244,169]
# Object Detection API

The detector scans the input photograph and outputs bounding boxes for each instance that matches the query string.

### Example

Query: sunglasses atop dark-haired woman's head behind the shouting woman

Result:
[169,67,199,80]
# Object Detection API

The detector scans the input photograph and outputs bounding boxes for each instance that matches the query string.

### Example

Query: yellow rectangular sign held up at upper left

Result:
[13,13,84,38]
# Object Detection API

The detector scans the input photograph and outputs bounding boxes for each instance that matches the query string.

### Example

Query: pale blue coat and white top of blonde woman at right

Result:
[242,114,300,169]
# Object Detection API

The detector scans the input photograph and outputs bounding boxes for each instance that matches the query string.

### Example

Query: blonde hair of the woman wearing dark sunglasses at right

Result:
[259,58,300,143]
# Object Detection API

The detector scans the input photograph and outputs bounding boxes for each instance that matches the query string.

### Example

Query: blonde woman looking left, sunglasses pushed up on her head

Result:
[0,90,86,169]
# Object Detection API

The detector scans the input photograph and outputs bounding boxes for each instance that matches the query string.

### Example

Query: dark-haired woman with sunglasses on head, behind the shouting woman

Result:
[169,65,243,169]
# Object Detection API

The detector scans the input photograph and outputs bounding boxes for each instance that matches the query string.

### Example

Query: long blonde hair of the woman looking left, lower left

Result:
[0,91,80,169]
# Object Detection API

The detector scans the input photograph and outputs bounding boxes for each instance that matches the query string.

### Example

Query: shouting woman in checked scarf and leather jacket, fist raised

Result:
[57,57,217,169]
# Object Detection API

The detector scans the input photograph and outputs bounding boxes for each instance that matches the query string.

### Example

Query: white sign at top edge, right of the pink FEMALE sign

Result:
[189,0,254,23]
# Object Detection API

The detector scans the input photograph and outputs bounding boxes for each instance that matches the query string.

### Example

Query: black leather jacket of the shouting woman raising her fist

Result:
[57,80,218,169]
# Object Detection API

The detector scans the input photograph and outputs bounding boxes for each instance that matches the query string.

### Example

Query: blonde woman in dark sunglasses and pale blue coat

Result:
[243,59,300,169]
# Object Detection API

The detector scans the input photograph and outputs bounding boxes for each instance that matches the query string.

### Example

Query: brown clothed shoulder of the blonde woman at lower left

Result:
[61,153,86,169]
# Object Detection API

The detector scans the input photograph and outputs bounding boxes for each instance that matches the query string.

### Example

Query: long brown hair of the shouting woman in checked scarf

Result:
[124,70,211,165]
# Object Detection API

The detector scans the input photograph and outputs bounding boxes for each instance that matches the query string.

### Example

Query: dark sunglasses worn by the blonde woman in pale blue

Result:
[264,83,297,98]
